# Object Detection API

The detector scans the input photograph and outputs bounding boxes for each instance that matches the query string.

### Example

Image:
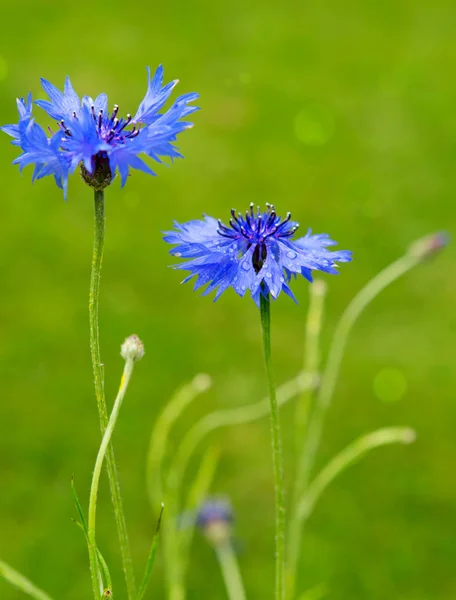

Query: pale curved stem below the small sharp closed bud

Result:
[87,357,135,600]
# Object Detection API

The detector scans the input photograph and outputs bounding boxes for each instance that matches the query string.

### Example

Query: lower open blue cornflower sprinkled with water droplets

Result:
[164,203,351,306]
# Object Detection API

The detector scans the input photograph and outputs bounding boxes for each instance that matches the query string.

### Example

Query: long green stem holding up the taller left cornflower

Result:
[89,190,136,600]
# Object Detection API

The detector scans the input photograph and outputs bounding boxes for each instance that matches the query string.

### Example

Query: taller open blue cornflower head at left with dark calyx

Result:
[0,66,198,197]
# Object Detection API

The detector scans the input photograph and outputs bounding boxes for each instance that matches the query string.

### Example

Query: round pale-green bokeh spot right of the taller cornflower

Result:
[294,103,334,146]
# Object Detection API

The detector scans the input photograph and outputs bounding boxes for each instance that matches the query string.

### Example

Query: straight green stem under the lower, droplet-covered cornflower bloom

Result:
[260,295,285,600]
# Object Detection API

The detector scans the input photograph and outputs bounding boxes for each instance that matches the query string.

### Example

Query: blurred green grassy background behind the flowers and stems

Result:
[0,0,456,600]
